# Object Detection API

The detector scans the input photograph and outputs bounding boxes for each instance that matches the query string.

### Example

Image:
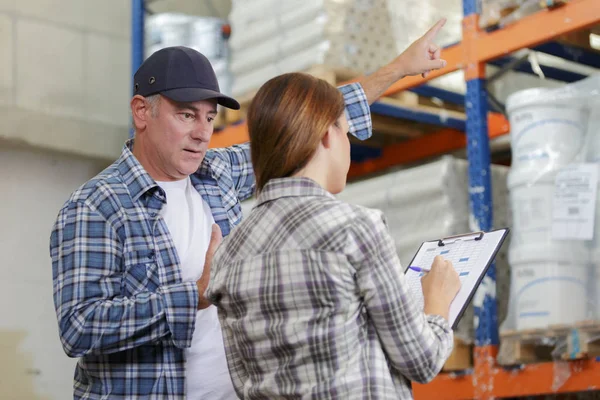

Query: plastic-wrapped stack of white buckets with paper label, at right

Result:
[503,76,600,330]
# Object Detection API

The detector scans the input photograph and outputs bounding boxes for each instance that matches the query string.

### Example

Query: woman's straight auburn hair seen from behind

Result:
[248,72,344,192]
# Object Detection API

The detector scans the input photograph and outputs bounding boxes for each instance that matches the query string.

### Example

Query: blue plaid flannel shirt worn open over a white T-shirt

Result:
[50,83,371,399]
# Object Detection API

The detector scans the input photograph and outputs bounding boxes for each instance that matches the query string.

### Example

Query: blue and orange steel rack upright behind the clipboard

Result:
[463,0,499,399]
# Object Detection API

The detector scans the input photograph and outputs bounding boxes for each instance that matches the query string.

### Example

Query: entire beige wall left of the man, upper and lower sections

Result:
[0,0,131,400]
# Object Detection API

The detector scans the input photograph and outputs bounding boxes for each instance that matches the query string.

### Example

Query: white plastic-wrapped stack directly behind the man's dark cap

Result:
[144,13,232,95]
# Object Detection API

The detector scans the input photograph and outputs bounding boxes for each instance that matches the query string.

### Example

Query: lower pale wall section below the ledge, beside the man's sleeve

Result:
[0,142,105,400]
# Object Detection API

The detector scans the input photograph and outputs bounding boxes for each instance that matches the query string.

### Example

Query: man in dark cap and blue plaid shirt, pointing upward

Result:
[50,22,445,400]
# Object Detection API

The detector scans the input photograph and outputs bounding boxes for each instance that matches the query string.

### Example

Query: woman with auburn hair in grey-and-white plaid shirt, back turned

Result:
[207,73,460,399]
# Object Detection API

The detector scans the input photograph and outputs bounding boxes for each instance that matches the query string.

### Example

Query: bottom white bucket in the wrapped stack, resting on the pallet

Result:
[509,243,591,330]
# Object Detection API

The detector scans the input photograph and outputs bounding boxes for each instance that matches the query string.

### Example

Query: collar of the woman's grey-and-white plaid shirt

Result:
[256,177,335,206]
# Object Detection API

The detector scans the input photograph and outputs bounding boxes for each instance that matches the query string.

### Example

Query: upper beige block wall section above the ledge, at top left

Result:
[0,0,131,159]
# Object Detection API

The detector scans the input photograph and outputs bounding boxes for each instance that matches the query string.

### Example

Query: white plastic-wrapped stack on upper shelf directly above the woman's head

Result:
[229,0,396,96]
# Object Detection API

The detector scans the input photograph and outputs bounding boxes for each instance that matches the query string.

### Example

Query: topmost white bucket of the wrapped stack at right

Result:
[506,88,588,170]
